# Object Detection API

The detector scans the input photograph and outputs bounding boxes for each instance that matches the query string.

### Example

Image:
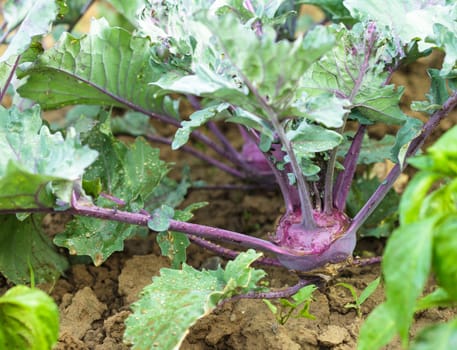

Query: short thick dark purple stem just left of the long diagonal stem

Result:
[333,125,367,212]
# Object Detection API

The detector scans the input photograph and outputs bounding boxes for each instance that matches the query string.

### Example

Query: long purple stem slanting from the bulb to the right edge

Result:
[348,91,457,234]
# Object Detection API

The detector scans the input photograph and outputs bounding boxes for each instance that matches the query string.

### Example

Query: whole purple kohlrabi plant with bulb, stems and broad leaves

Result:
[0,0,457,349]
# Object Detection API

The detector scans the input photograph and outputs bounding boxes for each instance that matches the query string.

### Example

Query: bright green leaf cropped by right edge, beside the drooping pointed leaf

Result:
[433,216,457,300]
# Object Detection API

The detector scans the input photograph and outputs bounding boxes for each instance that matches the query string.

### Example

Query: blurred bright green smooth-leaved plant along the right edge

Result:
[358,126,457,350]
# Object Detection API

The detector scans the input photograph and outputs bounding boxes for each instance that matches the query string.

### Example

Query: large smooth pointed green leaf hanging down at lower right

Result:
[382,218,436,345]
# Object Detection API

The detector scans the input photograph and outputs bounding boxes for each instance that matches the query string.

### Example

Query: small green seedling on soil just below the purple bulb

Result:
[263,284,317,325]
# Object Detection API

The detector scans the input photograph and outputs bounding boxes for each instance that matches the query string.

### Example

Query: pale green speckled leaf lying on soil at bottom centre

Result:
[124,250,264,349]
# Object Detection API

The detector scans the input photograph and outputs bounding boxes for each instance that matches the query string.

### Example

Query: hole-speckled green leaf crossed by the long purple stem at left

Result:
[54,124,168,265]
